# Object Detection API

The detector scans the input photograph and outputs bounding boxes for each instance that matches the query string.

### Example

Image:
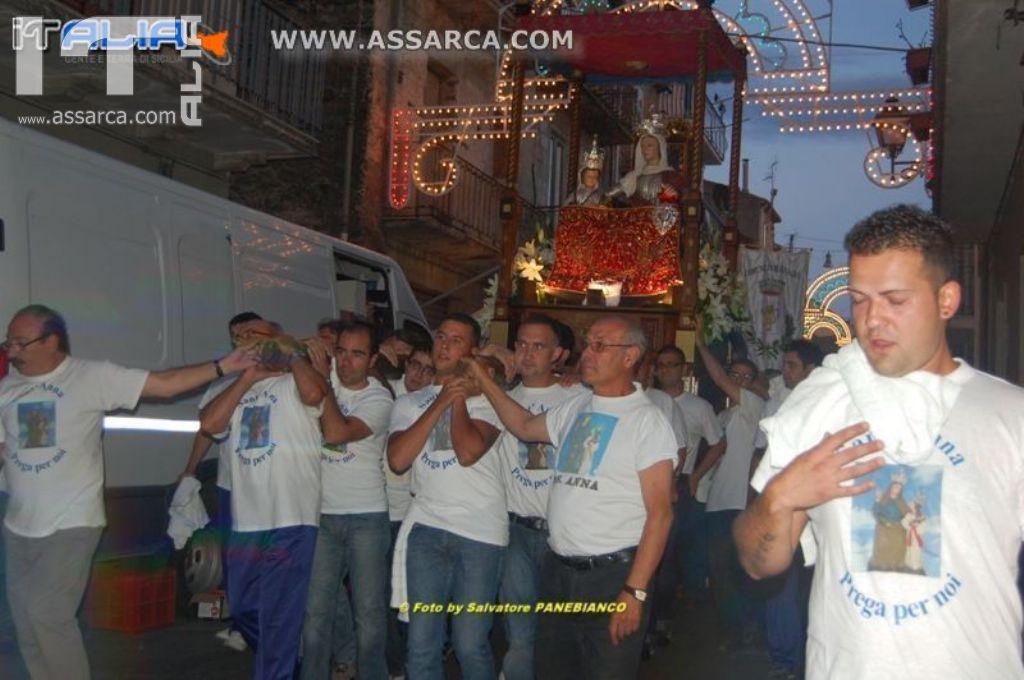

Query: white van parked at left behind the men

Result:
[0,120,427,553]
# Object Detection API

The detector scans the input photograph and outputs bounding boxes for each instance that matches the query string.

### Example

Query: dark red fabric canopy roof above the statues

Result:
[516,10,746,79]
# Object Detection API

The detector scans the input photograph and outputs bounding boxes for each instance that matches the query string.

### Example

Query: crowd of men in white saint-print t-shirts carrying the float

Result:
[0,207,1024,680]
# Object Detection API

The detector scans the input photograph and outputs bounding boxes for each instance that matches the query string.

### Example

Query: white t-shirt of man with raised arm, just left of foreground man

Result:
[706,389,765,512]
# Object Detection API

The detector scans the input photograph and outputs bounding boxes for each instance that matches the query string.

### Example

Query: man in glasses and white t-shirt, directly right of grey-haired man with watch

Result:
[654,345,725,602]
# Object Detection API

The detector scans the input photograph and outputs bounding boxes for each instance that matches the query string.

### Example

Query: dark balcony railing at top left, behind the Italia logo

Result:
[62,0,327,133]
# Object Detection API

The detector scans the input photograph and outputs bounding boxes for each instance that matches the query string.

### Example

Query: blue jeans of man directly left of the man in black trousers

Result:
[500,522,548,680]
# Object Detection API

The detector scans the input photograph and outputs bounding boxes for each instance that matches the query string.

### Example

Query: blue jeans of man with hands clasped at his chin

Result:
[405,524,505,680]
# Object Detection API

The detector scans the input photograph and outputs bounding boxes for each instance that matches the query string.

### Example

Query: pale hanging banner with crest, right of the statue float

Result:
[739,248,810,370]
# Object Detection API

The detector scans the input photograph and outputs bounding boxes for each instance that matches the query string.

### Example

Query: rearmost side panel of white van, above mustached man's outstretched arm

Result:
[25,147,169,368]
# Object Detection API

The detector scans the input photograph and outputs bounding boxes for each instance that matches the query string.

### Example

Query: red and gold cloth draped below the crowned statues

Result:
[545,206,682,297]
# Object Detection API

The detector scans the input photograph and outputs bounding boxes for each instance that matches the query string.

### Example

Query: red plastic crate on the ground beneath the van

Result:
[86,564,177,634]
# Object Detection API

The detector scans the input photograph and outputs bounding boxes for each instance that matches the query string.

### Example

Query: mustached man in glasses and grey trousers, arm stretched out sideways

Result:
[0,305,255,680]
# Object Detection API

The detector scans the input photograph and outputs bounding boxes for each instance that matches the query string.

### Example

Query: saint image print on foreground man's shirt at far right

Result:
[850,465,942,578]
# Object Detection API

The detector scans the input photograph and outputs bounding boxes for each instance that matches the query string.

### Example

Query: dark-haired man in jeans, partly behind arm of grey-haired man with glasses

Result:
[496,314,585,680]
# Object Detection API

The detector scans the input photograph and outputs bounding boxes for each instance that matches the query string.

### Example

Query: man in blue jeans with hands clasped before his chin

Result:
[387,313,508,680]
